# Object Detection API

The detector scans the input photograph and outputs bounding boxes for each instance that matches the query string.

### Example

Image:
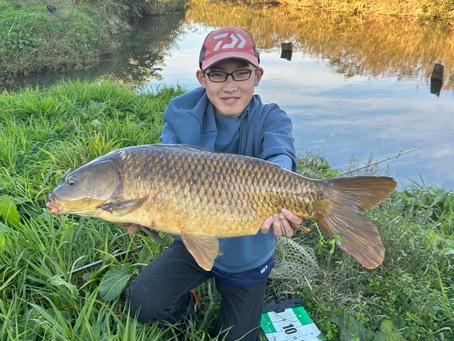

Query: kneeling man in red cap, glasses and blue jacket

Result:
[127,27,302,341]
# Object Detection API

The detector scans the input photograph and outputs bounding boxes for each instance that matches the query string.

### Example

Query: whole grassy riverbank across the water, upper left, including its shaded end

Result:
[0,0,187,87]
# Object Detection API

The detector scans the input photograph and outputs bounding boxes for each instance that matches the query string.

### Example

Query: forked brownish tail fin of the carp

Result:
[315,176,397,269]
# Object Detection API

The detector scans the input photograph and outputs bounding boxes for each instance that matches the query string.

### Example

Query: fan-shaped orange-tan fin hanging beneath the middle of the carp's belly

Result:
[180,231,219,271]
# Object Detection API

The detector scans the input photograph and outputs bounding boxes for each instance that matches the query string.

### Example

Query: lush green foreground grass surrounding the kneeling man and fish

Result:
[0,80,454,340]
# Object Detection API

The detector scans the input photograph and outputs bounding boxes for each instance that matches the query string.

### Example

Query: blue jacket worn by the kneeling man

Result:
[161,87,297,273]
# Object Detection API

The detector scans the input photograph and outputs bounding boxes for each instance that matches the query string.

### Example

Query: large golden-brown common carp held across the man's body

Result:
[46,145,397,270]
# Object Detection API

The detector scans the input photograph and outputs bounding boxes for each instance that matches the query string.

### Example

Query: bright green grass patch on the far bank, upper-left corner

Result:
[0,0,122,80]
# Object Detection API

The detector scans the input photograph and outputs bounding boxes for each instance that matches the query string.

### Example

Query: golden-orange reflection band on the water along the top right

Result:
[187,0,454,89]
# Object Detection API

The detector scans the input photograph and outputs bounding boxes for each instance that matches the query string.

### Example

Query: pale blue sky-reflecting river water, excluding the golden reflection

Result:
[7,18,454,190]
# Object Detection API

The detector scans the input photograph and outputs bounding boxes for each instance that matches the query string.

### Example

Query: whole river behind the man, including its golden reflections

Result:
[7,5,454,190]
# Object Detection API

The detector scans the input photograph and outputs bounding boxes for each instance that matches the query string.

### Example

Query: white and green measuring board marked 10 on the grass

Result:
[260,307,326,341]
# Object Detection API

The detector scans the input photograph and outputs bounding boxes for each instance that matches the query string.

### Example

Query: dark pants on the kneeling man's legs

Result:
[126,241,266,341]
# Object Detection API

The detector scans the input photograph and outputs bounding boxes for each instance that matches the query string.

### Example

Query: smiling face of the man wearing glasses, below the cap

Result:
[197,59,263,117]
